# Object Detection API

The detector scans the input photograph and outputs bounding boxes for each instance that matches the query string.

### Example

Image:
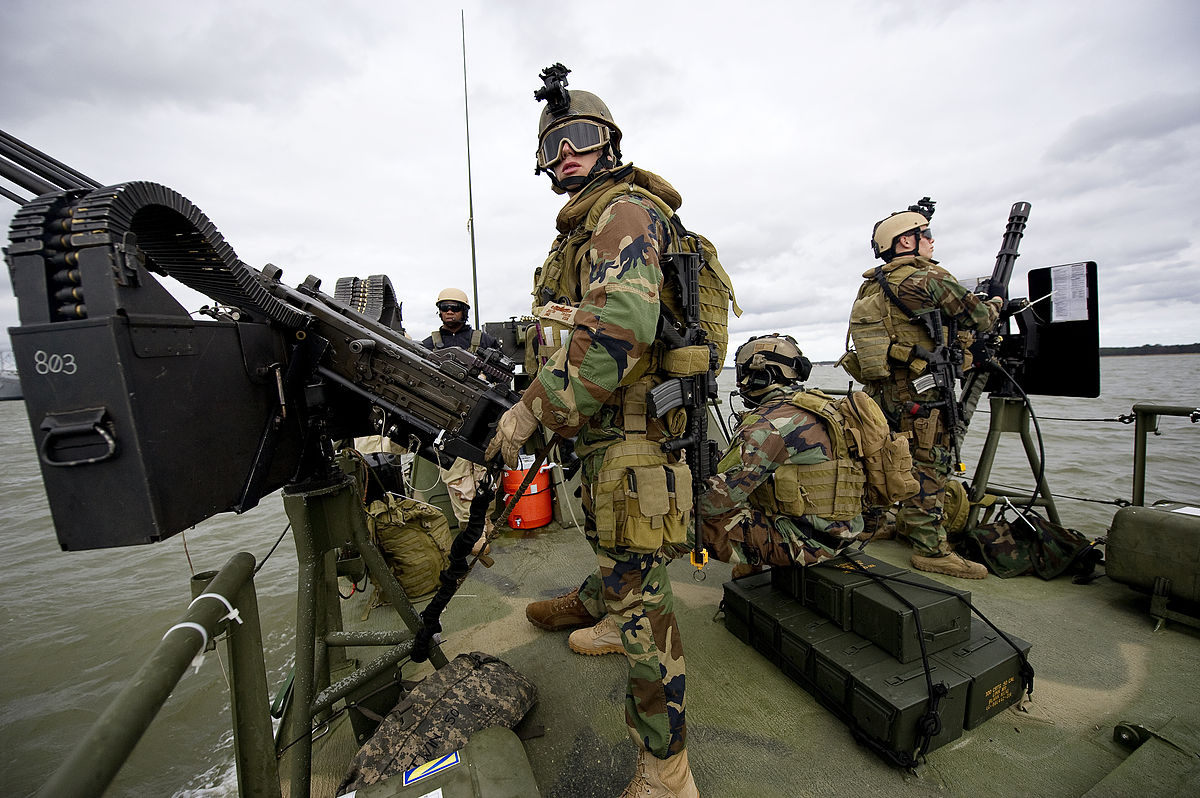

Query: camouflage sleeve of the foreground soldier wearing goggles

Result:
[522,196,665,437]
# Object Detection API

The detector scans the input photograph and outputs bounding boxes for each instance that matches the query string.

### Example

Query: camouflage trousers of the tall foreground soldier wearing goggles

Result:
[580,535,688,760]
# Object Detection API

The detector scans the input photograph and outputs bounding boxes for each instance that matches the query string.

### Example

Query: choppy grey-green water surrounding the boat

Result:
[0,355,1200,798]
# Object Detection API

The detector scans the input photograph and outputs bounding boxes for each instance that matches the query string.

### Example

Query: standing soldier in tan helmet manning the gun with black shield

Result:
[842,205,1003,580]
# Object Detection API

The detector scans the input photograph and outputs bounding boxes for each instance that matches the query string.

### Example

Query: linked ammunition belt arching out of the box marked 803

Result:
[10,181,307,328]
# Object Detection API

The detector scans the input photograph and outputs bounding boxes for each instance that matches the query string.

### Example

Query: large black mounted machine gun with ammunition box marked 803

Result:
[0,132,517,550]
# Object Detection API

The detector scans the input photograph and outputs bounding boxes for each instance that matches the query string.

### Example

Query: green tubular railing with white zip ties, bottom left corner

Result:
[37,552,281,798]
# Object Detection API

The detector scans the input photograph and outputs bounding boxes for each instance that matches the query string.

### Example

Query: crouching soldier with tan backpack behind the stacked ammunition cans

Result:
[698,334,863,568]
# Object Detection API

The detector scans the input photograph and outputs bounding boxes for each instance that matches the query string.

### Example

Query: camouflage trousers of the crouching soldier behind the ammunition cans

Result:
[703,508,863,565]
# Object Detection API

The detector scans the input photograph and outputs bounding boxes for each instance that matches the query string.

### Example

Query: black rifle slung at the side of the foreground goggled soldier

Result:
[648,236,719,569]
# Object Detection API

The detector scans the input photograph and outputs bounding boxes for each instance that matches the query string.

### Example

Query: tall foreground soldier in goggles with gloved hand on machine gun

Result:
[487,65,728,797]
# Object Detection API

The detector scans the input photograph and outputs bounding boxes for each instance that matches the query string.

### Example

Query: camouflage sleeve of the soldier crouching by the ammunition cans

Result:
[700,403,833,517]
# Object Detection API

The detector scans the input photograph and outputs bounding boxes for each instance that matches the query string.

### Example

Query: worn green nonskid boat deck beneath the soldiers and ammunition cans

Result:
[328,527,1200,798]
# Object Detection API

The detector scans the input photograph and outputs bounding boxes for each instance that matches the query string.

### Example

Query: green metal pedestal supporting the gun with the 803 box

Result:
[276,474,446,796]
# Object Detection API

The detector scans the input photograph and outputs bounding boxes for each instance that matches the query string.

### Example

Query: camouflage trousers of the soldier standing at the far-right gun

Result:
[866,379,953,557]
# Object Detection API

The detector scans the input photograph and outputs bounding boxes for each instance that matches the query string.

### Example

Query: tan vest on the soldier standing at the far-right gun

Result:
[838,256,946,383]
